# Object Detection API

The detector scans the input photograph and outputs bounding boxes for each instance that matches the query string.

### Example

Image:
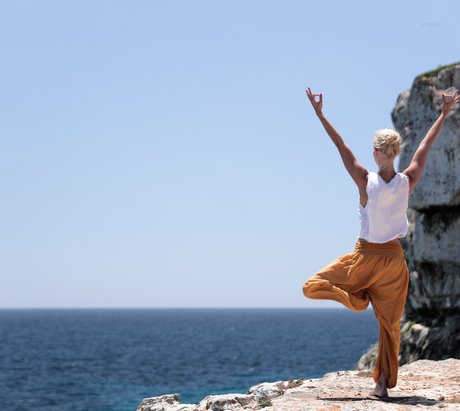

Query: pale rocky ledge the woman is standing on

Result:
[137,358,460,411]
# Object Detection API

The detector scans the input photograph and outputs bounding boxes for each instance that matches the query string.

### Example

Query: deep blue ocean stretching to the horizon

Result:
[0,308,378,411]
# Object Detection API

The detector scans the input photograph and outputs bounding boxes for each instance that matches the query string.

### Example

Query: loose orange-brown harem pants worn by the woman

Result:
[303,240,409,388]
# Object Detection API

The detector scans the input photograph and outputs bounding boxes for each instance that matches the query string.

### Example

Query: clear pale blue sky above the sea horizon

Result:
[0,0,460,307]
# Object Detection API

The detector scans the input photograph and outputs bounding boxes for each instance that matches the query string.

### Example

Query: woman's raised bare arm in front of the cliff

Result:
[403,90,460,193]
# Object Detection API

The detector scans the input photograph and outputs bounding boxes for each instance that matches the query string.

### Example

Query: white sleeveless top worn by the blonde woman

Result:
[358,171,409,243]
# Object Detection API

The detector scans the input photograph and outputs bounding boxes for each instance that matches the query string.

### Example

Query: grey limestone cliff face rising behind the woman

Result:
[357,63,460,369]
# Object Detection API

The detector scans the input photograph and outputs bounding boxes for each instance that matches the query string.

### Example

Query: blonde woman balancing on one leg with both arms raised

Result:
[303,88,460,398]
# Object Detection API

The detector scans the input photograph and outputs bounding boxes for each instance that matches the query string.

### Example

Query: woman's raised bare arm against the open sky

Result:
[305,87,368,190]
